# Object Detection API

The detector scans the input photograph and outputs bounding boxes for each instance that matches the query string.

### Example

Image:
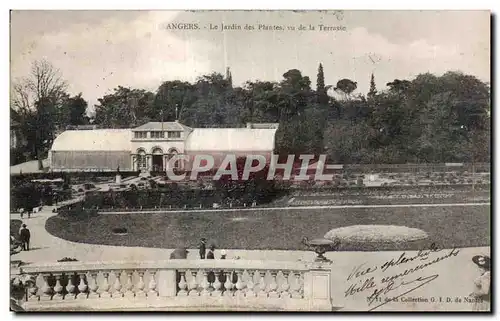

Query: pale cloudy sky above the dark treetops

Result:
[10,11,490,110]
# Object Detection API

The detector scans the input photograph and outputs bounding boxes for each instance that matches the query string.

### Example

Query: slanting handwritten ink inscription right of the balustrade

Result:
[344,243,460,311]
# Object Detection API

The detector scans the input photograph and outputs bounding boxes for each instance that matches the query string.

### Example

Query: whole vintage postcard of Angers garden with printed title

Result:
[10,10,491,312]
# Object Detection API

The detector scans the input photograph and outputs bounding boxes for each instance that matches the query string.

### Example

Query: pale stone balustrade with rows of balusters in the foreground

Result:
[17,260,332,311]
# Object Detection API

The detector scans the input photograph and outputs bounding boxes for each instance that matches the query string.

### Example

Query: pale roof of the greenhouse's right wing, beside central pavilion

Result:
[185,128,277,152]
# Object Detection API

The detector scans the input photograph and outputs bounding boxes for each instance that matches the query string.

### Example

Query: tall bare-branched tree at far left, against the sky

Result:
[11,60,67,169]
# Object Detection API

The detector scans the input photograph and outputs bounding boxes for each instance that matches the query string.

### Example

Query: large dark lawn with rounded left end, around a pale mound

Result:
[46,206,490,251]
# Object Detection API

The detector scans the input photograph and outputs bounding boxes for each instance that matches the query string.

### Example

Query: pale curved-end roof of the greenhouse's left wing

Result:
[51,129,131,151]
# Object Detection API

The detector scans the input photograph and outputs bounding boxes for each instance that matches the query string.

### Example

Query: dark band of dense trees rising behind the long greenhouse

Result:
[11,60,491,164]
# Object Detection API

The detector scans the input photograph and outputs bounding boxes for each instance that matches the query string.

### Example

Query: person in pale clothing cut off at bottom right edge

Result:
[469,255,491,311]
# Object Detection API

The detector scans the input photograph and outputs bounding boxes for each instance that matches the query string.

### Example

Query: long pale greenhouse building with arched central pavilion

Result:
[49,121,278,172]
